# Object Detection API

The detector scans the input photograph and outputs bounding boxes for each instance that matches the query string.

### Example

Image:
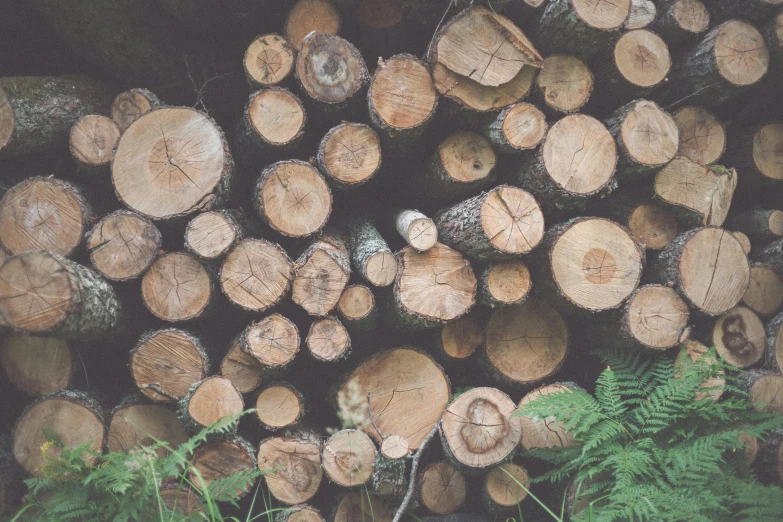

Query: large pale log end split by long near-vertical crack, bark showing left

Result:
[649,227,750,316]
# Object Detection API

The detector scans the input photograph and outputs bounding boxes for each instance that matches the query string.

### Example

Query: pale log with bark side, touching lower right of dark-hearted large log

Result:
[591,285,690,351]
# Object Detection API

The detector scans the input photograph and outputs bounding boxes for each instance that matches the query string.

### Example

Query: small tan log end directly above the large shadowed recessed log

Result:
[478,261,532,308]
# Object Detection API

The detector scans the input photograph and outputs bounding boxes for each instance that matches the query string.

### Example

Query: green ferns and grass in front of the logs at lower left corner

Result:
[11,412,279,522]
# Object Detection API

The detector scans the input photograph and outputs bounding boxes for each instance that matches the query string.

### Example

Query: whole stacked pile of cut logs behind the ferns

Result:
[0,0,783,522]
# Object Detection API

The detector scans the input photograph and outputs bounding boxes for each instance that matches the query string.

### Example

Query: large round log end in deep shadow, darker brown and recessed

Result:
[480,298,569,388]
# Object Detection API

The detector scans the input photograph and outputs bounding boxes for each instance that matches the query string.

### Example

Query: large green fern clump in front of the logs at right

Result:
[515,349,783,522]
